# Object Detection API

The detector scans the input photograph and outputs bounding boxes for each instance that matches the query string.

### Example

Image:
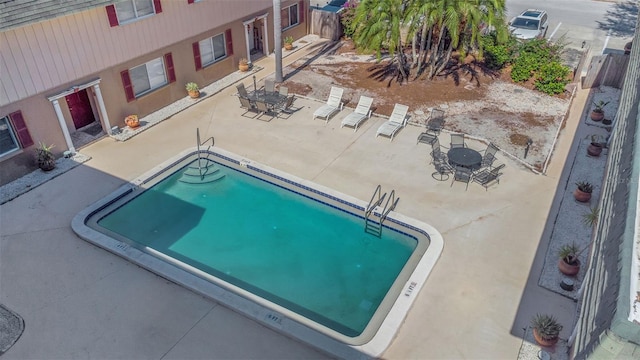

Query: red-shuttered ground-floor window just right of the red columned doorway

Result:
[120,53,176,102]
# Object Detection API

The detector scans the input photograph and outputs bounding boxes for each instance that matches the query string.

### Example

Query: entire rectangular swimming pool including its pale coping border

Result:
[73,149,442,356]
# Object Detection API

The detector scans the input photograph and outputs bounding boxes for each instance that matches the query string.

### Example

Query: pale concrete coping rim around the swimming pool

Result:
[71,147,444,358]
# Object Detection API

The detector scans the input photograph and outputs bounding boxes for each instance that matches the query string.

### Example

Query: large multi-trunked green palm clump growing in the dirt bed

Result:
[354,0,506,78]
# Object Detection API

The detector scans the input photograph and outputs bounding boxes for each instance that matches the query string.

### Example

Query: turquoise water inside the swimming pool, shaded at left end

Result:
[97,158,418,337]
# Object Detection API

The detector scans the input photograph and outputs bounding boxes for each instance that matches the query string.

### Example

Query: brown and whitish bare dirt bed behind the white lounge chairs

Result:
[283,41,570,170]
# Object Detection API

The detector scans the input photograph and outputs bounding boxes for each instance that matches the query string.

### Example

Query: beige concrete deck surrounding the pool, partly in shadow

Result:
[0,35,589,359]
